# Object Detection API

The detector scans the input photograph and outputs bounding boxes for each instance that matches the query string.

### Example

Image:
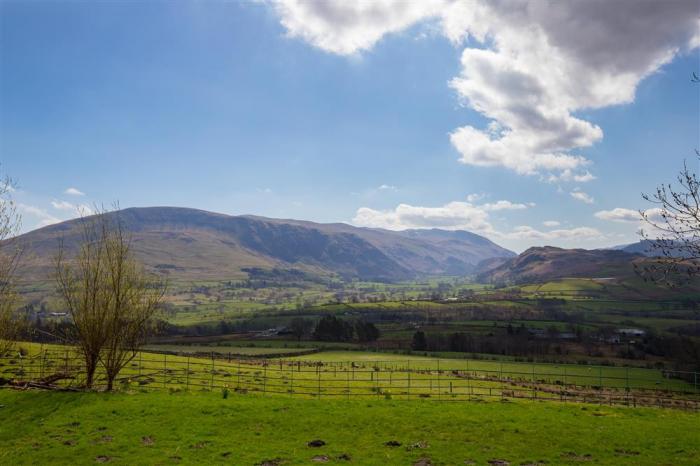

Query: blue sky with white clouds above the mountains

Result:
[0,0,700,251]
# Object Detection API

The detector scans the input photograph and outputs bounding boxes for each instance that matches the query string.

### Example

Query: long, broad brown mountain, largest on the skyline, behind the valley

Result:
[12,207,515,281]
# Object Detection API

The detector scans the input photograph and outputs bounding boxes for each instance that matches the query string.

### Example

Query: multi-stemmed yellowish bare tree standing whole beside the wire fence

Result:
[56,209,165,390]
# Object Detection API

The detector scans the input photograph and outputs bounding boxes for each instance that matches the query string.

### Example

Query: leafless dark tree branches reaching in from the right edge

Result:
[639,153,700,285]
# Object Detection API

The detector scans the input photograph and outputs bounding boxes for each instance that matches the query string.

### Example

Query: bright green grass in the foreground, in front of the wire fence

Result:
[0,390,700,465]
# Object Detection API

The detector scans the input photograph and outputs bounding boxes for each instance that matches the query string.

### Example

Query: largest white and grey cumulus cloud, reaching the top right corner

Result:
[273,0,700,183]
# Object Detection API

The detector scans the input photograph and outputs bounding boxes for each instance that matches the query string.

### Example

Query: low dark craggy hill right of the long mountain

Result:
[477,246,643,283]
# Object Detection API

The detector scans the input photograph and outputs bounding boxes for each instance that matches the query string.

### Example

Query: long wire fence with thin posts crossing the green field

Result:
[0,347,700,410]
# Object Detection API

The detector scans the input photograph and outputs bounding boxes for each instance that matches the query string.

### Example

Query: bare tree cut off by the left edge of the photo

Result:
[0,177,22,355]
